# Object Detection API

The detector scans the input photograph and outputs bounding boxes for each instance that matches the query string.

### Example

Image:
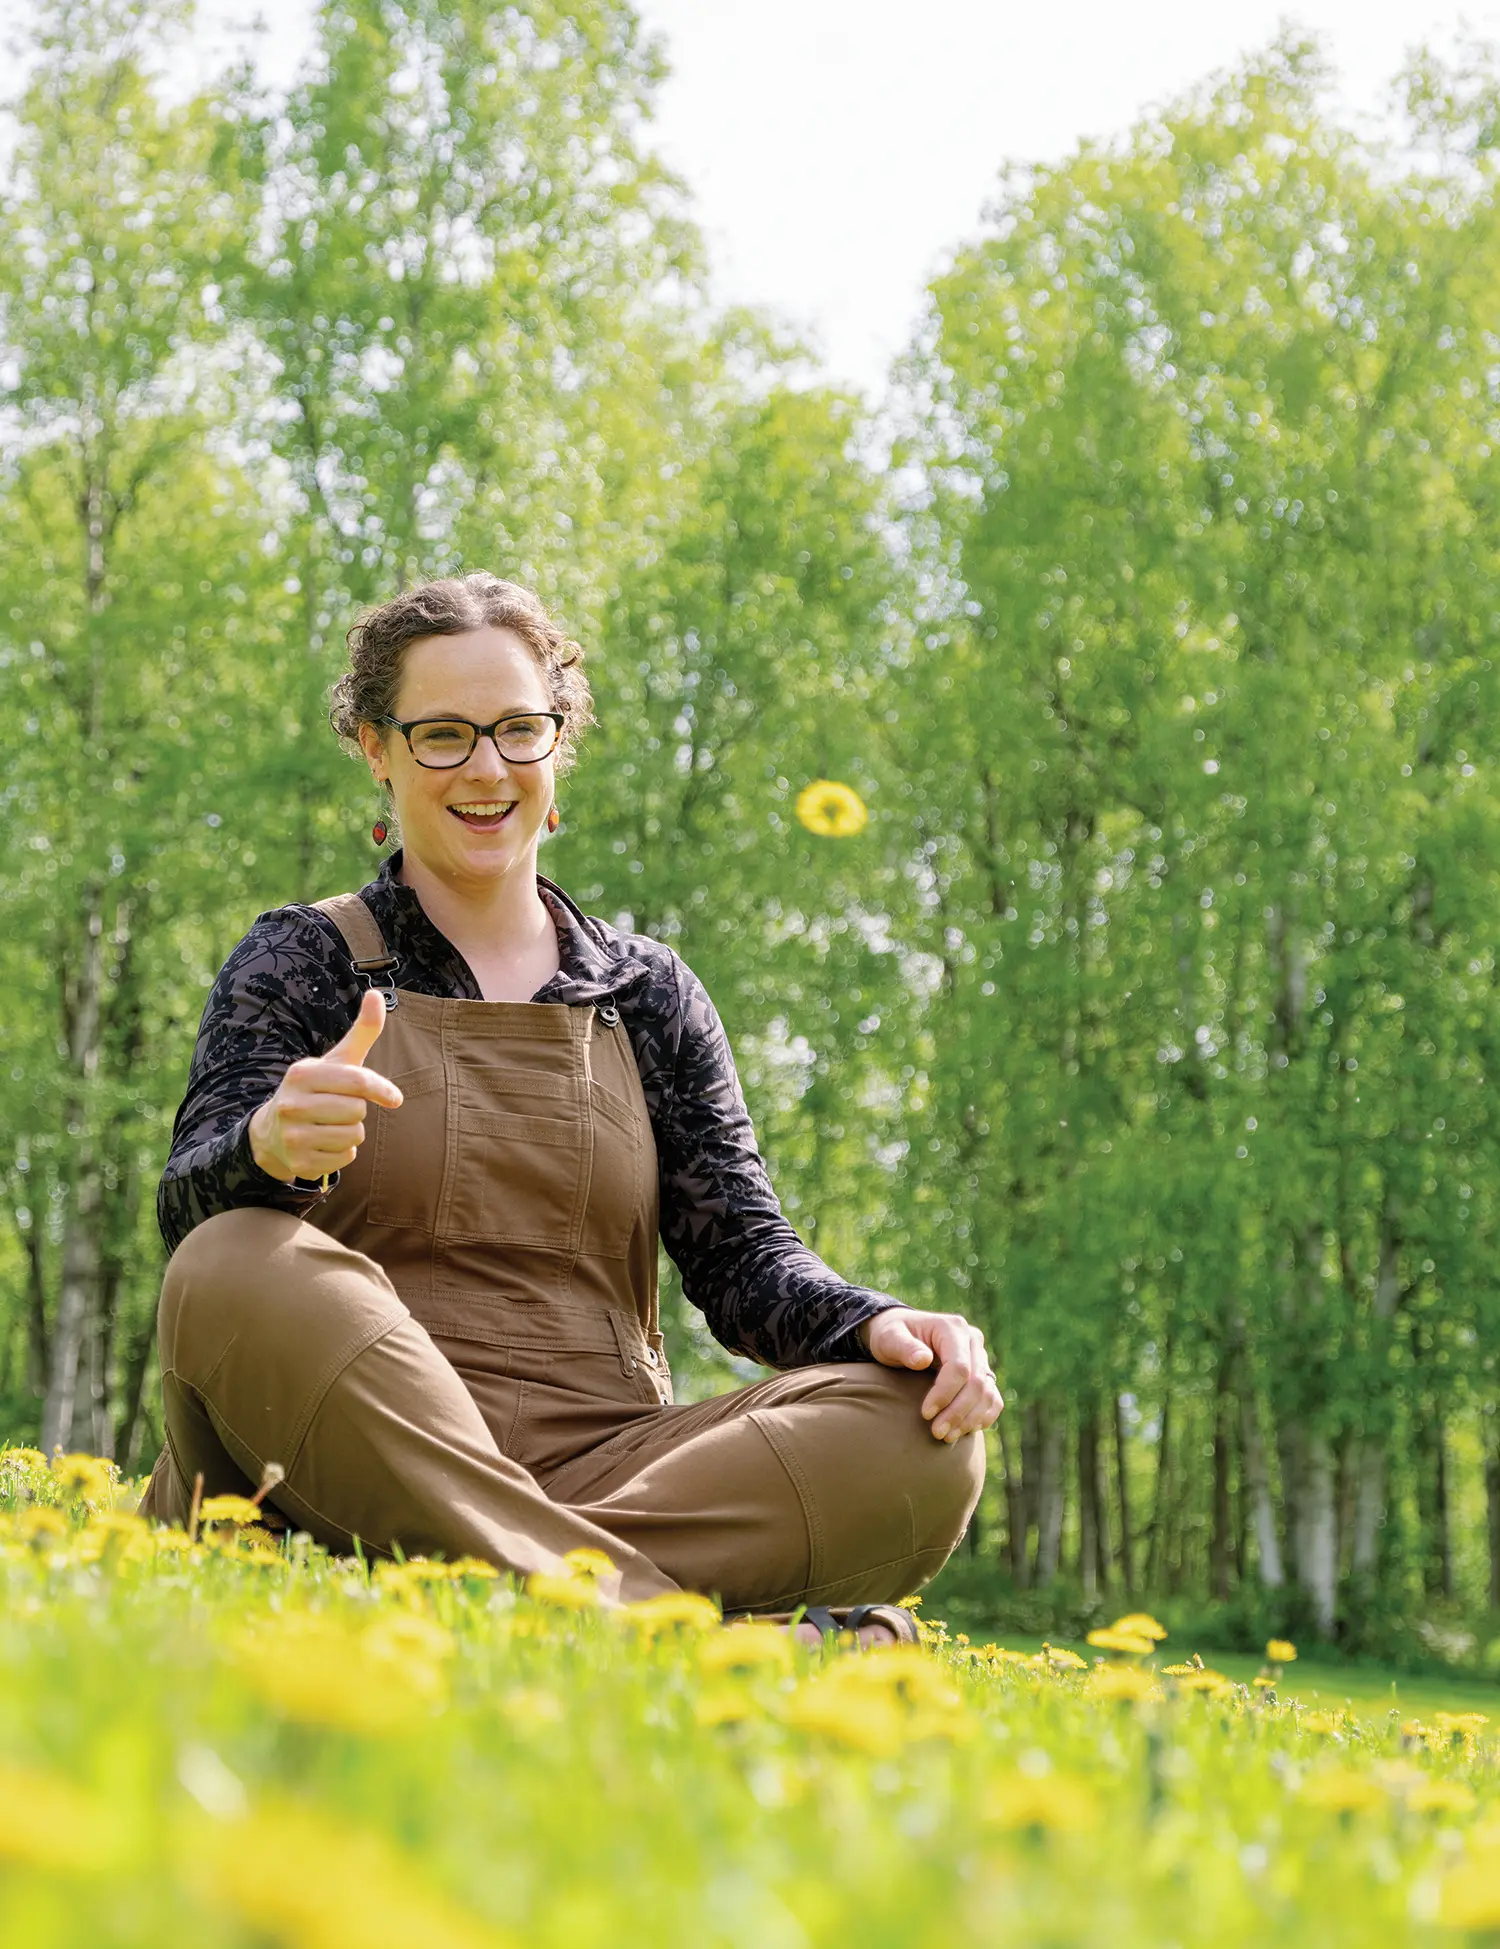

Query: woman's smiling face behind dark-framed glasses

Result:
[360,624,555,891]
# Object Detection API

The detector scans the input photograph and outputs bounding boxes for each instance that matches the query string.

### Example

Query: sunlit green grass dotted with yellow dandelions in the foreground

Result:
[0,1450,1500,1949]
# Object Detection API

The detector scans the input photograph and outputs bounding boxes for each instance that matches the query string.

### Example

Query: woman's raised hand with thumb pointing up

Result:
[249,988,401,1185]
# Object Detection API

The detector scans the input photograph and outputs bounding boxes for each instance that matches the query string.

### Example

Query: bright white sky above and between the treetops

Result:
[181,0,1500,392]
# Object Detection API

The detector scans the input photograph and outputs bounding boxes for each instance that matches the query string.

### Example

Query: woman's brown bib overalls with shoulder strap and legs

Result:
[142,895,984,1610]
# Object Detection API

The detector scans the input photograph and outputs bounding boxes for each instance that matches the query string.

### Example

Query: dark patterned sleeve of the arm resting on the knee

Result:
[656,957,902,1366]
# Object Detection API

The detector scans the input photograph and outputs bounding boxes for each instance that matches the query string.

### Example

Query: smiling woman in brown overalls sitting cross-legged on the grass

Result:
[142,575,999,1637]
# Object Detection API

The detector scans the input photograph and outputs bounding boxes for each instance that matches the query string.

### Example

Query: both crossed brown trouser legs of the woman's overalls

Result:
[142,1210,984,1610]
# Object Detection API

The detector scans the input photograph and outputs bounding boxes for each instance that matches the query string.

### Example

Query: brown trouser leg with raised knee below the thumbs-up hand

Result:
[142,1208,672,1598]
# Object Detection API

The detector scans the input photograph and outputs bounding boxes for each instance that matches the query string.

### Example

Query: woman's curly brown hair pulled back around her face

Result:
[327,569,594,774]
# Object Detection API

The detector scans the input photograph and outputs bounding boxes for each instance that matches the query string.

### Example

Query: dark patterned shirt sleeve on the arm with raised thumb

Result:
[156,908,358,1251]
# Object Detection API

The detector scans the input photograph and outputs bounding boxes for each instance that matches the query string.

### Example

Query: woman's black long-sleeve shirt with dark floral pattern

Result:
[156,854,900,1366]
